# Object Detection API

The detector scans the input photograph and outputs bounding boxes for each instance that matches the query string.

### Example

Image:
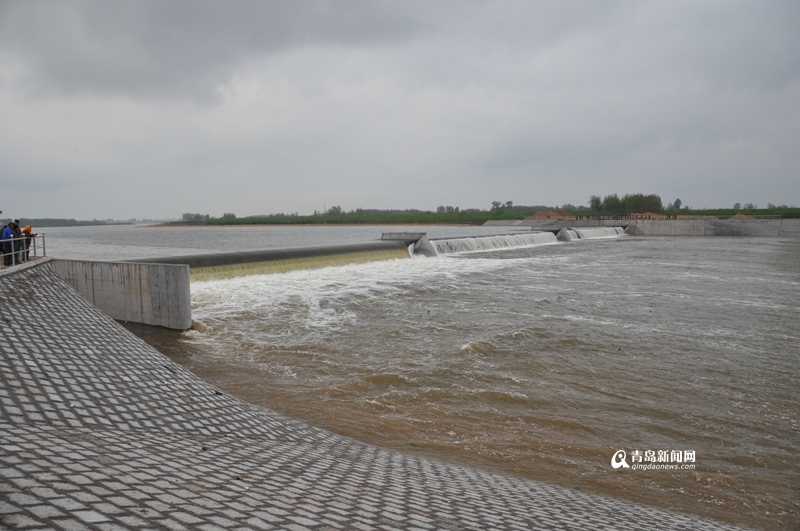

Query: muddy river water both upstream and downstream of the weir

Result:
[48,227,800,529]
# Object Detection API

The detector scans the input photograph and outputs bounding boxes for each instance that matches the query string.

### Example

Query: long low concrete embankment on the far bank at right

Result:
[486,219,800,238]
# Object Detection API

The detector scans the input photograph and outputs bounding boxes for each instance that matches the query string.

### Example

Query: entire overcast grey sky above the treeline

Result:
[0,0,800,219]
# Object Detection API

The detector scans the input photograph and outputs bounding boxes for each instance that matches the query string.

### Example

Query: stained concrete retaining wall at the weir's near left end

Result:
[52,260,192,330]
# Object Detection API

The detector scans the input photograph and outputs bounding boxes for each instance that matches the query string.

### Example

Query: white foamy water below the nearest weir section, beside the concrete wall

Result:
[192,256,532,346]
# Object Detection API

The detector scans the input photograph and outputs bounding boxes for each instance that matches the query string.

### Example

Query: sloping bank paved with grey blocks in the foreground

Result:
[0,259,738,531]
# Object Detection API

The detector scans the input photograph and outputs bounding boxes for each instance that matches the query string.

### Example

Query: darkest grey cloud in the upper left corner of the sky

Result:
[0,0,423,98]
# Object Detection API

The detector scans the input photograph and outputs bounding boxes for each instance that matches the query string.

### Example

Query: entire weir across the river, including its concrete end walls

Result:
[42,219,800,330]
